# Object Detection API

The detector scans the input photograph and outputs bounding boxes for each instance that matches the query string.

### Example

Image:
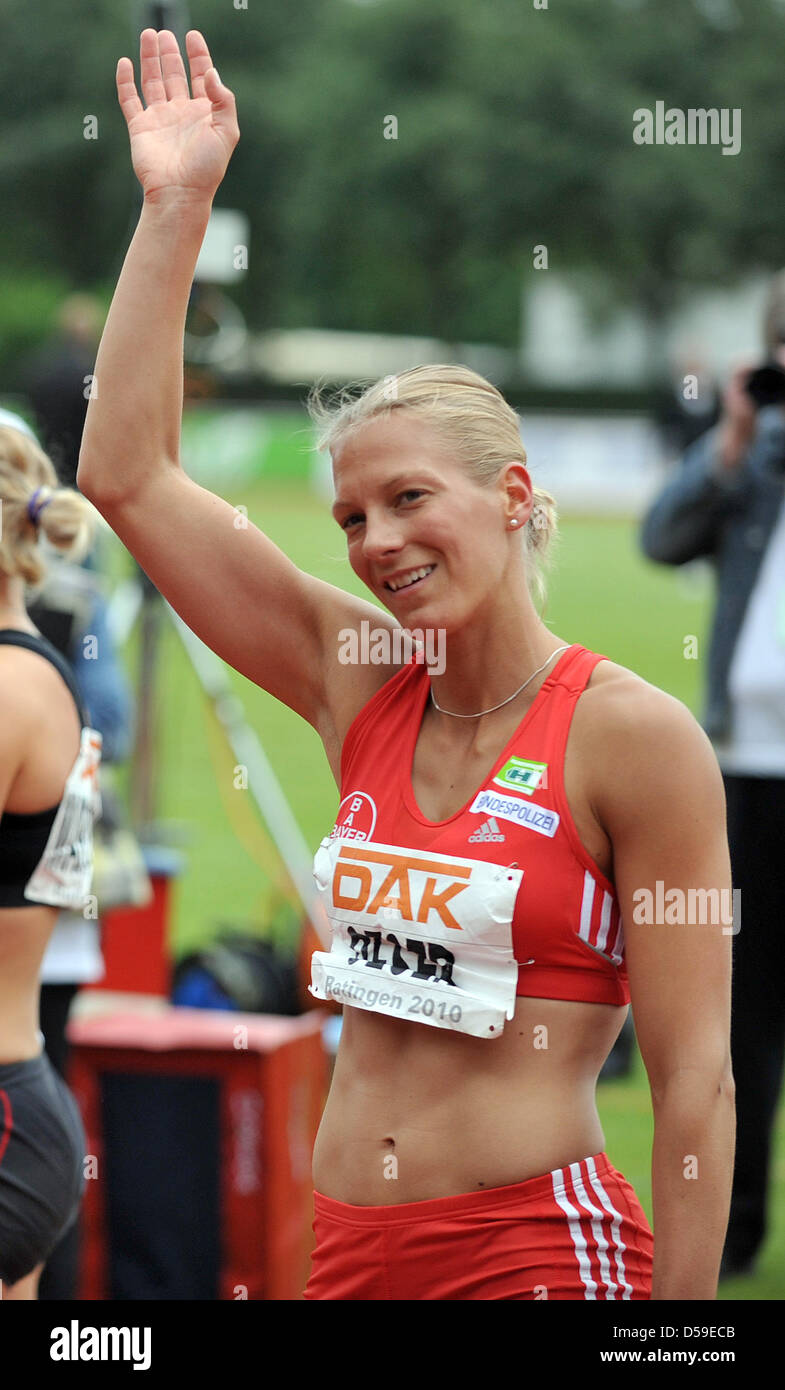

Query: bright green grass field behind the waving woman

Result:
[106,481,785,1300]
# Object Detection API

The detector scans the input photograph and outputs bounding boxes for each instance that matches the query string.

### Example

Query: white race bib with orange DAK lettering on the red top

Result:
[310,838,524,1037]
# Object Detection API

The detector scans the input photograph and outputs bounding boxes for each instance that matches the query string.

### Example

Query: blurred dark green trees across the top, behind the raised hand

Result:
[0,0,785,373]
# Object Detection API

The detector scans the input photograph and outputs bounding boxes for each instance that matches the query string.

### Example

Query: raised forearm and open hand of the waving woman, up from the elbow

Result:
[78,29,240,505]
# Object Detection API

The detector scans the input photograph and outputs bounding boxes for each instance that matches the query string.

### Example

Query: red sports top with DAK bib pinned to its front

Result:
[311,644,629,1037]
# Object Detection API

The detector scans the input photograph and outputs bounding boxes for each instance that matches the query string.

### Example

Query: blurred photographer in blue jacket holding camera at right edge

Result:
[641,271,785,1277]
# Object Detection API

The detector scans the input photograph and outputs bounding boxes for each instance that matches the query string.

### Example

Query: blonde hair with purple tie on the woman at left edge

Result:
[0,424,94,588]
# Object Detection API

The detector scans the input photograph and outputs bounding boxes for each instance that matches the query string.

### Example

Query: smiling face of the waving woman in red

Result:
[332,411,525,630]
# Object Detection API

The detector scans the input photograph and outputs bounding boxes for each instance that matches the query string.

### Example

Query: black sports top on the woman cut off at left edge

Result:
[0,627,88,908]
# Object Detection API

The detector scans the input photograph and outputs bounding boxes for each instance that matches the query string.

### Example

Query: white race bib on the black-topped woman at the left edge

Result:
[25,728,101,910]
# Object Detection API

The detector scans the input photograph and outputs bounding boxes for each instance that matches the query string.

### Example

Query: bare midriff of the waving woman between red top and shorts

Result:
[313,998,627,1207]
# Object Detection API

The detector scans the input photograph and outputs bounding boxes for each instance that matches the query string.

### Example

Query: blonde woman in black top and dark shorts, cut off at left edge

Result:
[0,411,101,1300]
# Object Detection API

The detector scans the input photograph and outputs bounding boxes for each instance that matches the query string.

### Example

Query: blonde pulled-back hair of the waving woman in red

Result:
[307,364,557,602]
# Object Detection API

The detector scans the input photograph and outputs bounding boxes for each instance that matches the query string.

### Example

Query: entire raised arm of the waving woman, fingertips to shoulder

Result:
[76,29,395,744]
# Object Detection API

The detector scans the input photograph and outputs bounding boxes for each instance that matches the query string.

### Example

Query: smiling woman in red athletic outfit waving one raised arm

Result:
[78,29,734,1300]
